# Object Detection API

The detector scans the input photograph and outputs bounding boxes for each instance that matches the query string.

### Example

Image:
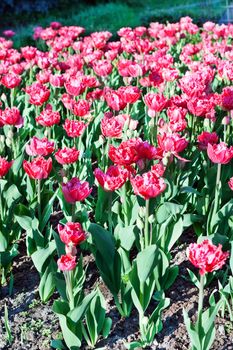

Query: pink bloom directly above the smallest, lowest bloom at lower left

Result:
[57,222,86,246]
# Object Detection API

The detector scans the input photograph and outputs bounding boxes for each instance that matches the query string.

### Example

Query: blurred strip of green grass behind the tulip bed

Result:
[0,0,228,47]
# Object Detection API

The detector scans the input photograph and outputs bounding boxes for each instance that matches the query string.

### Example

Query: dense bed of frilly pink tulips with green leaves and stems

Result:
[0,17,233,350]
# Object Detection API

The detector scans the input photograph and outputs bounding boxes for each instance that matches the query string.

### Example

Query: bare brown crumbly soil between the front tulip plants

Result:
[0,234,233,350]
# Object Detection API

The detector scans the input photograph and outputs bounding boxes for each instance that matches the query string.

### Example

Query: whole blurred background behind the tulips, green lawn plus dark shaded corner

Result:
[0,0,226,47]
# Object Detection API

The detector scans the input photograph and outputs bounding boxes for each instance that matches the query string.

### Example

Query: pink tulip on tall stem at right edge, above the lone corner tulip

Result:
[207,142,233,164]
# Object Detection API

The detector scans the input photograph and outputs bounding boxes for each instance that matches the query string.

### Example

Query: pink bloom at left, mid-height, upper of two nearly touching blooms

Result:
[26,136,54,156]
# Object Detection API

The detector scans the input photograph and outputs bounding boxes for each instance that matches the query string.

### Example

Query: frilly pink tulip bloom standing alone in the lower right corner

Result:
[187,239,229,275]
